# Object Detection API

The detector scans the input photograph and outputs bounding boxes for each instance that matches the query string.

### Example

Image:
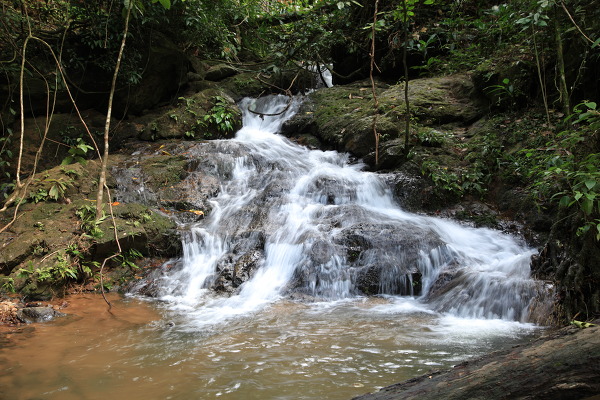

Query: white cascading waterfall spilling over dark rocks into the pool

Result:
[139,96,535,325]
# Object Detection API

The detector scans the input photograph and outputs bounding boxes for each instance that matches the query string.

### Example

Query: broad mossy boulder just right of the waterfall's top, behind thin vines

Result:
[282,75,485,167]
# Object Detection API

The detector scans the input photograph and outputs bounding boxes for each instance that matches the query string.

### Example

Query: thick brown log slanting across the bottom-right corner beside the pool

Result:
[354,320,600,400]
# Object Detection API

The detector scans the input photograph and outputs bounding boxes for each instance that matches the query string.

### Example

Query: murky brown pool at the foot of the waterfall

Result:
[0,295,535,400]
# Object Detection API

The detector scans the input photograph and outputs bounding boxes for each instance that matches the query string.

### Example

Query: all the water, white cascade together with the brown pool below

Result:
[0,96,536,399]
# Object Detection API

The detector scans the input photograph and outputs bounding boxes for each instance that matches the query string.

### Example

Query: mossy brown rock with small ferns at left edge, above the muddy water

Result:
[0,155,181,300]
